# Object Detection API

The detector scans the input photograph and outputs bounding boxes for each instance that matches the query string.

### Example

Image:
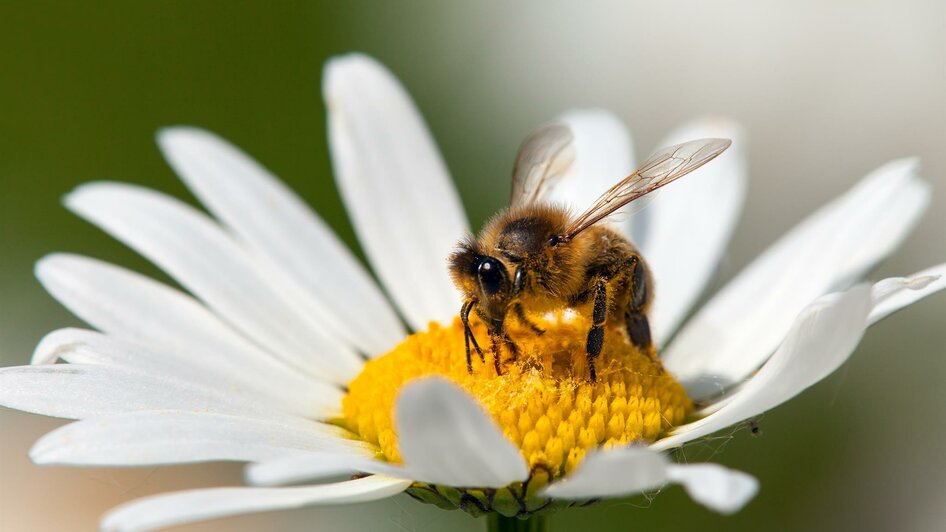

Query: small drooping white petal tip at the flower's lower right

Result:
[667,464,759,514]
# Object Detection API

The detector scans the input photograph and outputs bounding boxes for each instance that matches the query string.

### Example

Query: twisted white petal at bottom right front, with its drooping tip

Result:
[542,446,759,513]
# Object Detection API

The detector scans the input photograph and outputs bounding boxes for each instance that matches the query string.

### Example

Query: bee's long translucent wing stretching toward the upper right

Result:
[565,139,732,238]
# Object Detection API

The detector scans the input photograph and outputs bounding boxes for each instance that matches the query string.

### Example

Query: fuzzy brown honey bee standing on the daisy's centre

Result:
[448,123,731,382]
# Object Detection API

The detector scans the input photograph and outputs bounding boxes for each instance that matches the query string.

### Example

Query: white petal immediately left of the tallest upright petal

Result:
[158,127,404,354]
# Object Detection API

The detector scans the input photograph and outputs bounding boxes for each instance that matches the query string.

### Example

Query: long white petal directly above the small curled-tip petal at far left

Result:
[33,253,324,397]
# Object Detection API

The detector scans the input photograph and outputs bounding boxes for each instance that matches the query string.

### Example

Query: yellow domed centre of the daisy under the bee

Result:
[339,315,693,484]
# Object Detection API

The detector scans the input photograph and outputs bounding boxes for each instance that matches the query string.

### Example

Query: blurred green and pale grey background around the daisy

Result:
[0,0,946,531]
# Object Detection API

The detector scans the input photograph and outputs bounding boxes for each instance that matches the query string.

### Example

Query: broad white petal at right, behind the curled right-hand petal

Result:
[658,160,929,399]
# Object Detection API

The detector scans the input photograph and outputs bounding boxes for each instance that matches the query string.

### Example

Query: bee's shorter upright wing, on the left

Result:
[509,122,575,205]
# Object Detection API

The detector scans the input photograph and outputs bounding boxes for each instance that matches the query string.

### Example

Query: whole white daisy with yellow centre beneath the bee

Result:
[0,51,946,530]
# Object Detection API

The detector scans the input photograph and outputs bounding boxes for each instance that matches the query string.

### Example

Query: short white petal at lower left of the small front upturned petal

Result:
[246,453,414,486]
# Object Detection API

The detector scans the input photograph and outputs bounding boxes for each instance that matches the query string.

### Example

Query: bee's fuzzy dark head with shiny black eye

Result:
[450,239,514,322]
